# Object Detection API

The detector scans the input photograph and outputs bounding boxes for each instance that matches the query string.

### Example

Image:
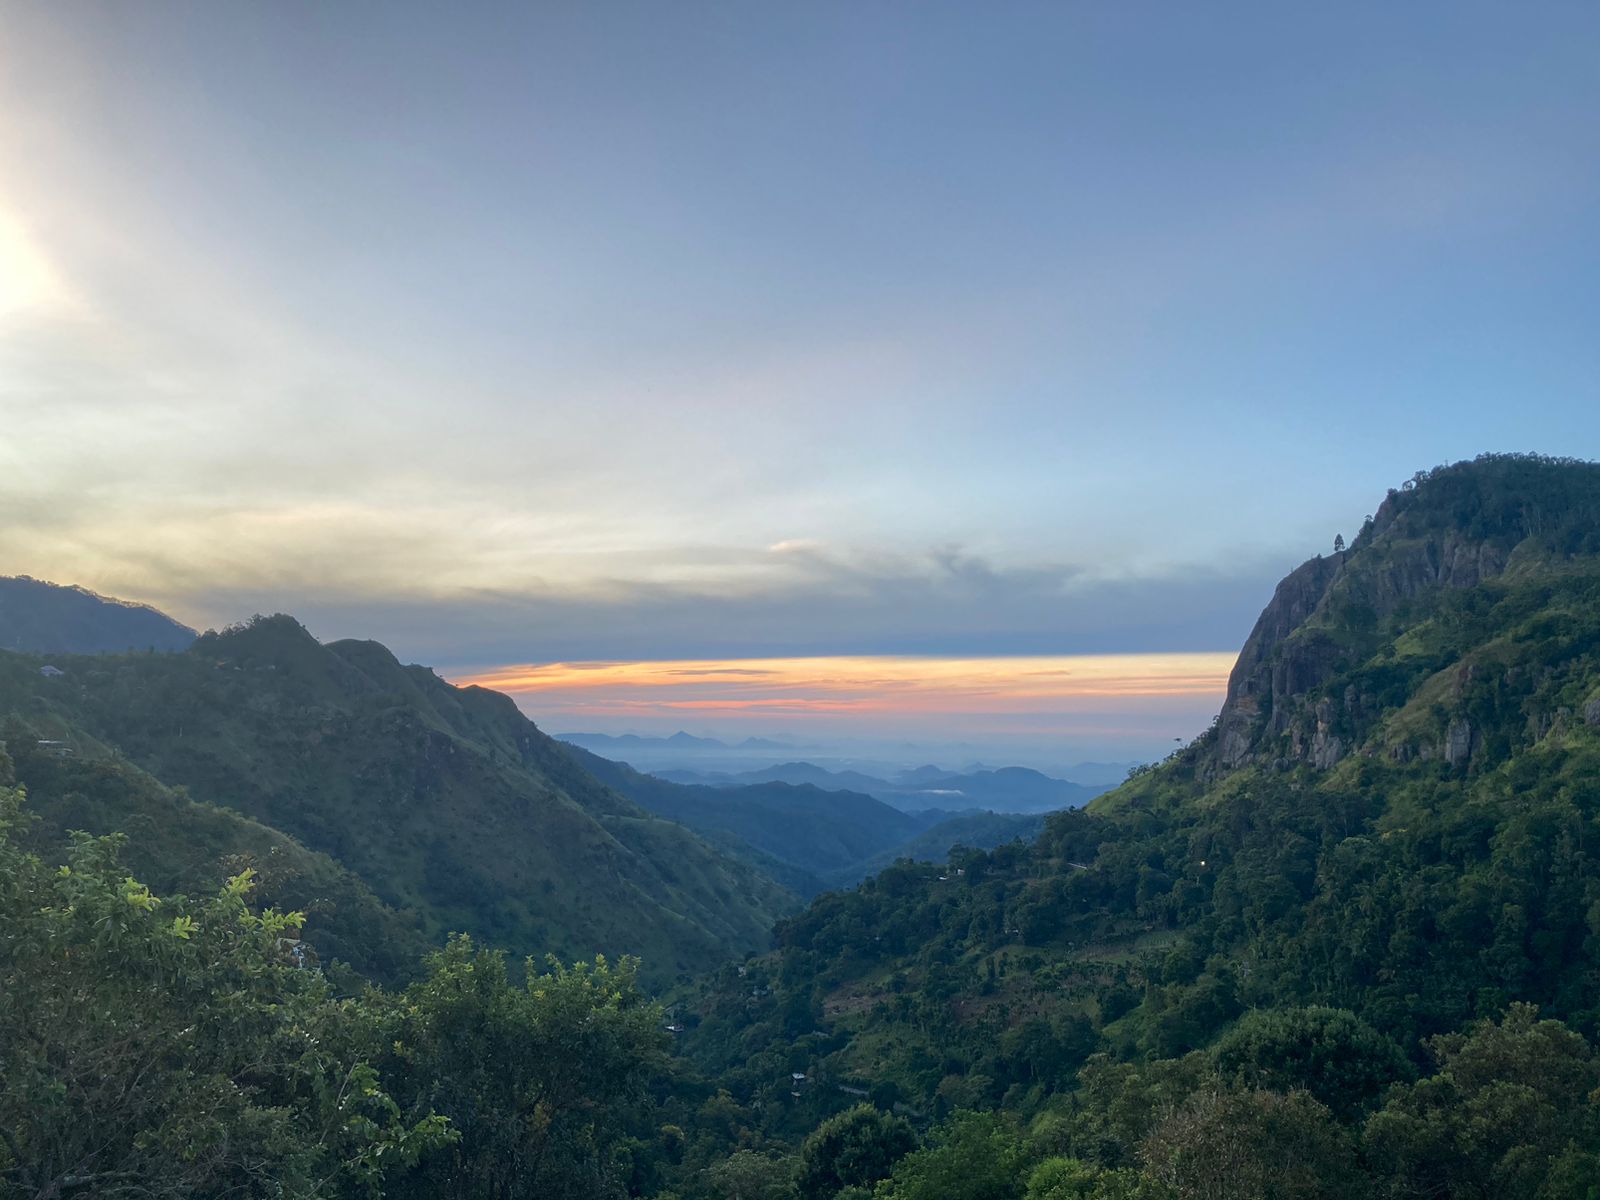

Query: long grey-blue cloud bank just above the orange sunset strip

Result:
[124,550,1293,678]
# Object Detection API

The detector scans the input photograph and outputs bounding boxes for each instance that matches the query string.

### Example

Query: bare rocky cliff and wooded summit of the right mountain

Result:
[1210,456,1600,778]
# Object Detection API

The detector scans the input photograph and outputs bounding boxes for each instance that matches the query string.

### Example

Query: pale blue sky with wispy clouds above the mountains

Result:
[0,0,1600,761]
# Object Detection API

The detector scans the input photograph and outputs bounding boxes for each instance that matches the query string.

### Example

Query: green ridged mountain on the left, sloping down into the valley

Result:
[0,616,794,979]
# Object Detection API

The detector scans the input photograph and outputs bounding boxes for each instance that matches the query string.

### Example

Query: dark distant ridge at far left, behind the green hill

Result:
[0,574,195,654]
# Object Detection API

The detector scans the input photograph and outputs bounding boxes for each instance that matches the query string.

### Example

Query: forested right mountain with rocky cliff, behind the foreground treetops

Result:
[691,458,1600,1128]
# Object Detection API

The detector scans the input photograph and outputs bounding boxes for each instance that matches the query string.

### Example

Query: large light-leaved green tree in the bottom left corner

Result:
[0,787,451,1200]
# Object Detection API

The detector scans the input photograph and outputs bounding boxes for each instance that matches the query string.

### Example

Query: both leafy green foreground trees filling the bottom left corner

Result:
[0,771,662,1200]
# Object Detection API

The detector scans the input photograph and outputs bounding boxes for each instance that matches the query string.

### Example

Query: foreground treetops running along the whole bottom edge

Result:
[9,748,1600,1200]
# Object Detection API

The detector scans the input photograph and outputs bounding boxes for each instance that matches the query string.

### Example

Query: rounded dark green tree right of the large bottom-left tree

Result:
[378,936,667,1200]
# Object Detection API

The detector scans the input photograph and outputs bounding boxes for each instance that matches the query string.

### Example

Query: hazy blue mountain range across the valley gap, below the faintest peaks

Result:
[654,762,1110,813]
